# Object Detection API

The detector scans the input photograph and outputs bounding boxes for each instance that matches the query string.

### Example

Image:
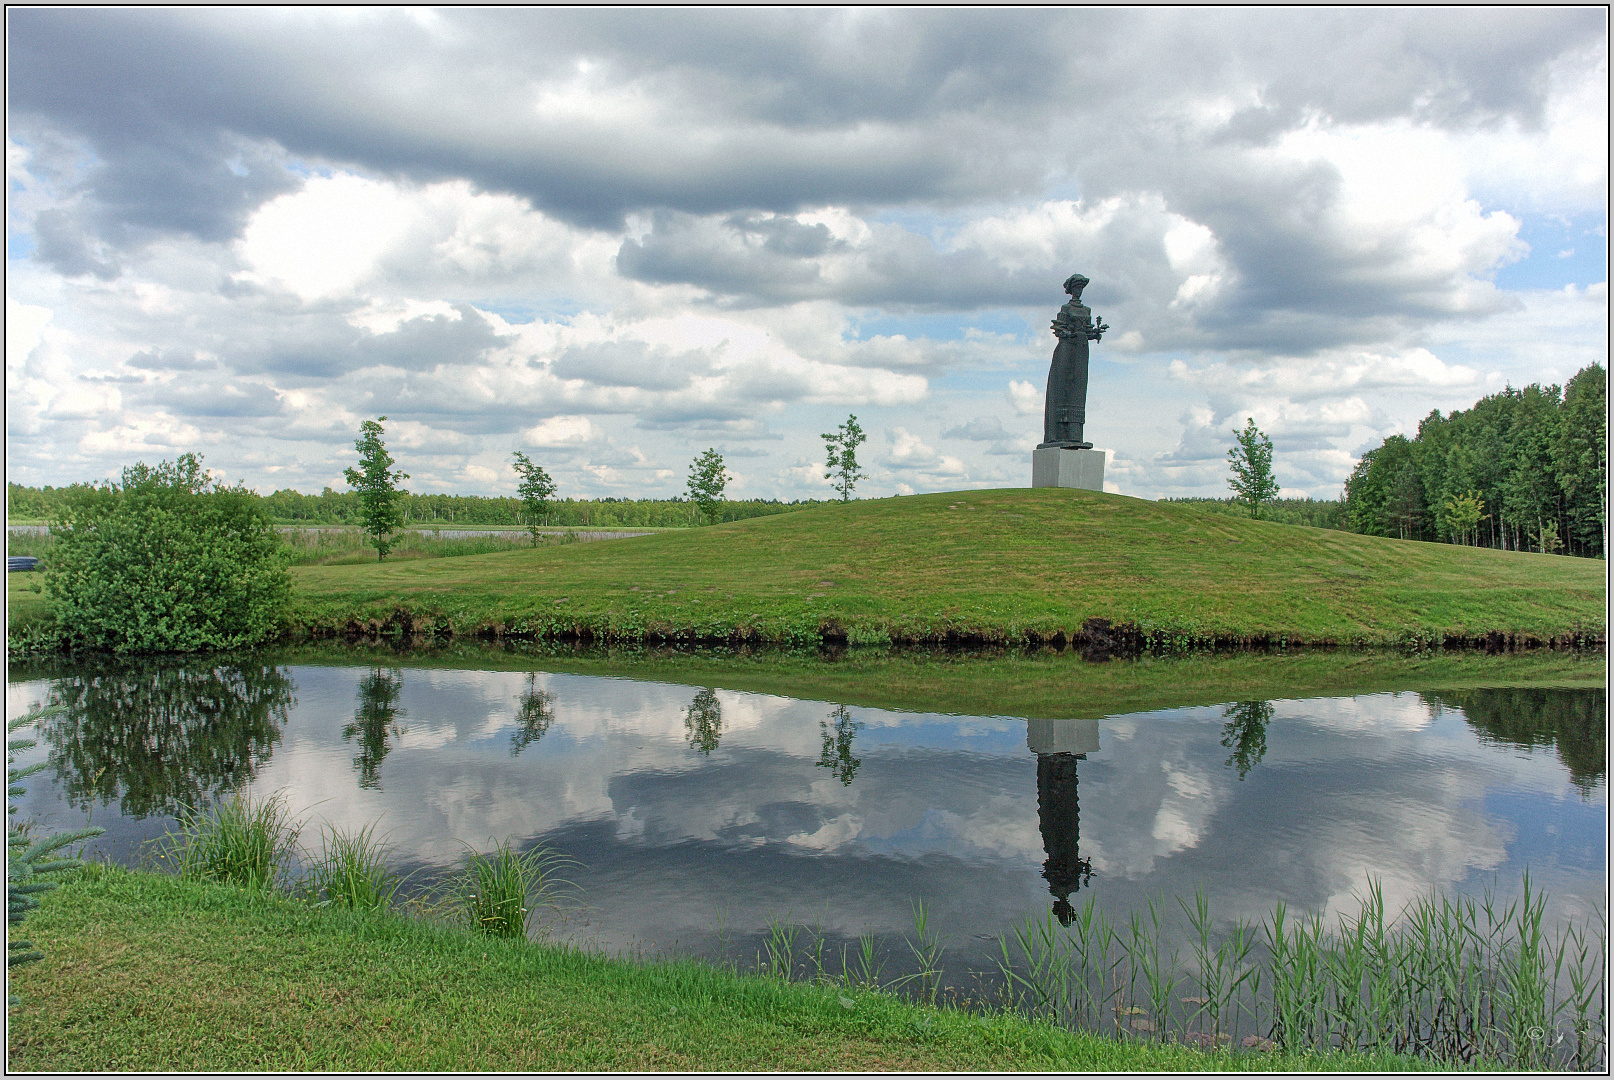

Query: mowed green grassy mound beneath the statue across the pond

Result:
[292,489,1606,644]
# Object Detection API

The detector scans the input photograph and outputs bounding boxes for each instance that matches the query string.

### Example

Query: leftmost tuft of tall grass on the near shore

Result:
[158,791,302,888]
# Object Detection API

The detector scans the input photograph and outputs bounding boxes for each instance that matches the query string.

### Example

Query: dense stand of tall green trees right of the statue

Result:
[1344,363,1608,557]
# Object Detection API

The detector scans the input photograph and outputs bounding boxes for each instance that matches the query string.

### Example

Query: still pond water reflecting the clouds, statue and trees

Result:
[8,662,1608,970]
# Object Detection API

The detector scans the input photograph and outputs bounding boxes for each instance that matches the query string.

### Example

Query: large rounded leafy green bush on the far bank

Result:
[45,454,291,652]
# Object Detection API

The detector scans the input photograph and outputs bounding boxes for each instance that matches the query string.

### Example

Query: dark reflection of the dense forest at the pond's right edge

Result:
[1422,686,1609,796]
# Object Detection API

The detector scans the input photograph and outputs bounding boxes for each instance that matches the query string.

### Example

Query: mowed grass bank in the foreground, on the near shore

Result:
[6,867,1424,1072]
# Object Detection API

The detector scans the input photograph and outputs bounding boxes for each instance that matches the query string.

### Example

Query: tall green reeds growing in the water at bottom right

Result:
[999,875,1608,1070]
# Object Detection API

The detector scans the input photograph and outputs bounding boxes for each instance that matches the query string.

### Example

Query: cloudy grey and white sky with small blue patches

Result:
[6,8,1608,499]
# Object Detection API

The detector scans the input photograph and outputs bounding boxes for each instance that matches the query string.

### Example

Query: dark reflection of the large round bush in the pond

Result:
[40,660,294,818]
